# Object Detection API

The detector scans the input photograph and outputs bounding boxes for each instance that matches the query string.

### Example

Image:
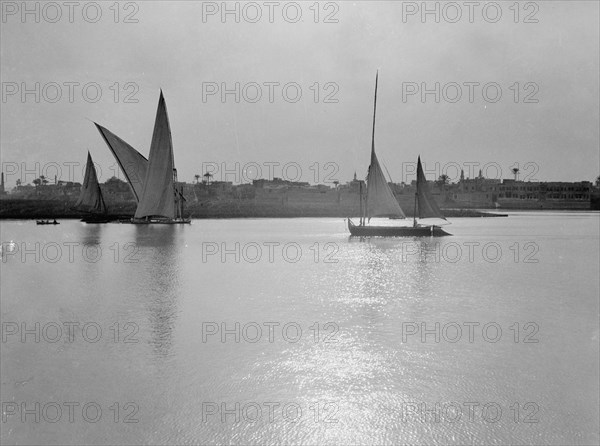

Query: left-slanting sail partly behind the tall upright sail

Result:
[94,123,148,203]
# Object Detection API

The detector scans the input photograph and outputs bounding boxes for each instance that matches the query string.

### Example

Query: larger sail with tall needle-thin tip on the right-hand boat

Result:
[367,74,406,218]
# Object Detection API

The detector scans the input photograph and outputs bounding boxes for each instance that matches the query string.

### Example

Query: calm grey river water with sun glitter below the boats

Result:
[0,212,600,445]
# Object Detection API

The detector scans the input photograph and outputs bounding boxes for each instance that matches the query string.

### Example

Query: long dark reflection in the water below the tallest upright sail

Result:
[134,225,184,358]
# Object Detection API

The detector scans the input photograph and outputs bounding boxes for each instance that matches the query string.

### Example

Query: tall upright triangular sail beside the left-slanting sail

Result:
[135,91,175,219]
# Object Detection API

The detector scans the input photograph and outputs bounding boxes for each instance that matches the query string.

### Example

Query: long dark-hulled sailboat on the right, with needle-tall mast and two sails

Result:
[348,73,450,237]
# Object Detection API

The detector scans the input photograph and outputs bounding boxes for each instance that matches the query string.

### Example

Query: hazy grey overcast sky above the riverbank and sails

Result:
[0,1,600,186]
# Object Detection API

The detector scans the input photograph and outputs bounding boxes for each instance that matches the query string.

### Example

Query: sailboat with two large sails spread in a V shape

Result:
[94,90,191,224]
